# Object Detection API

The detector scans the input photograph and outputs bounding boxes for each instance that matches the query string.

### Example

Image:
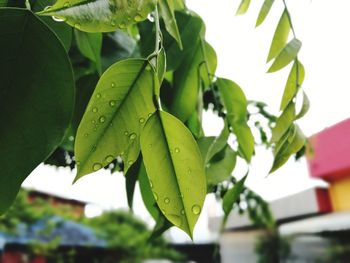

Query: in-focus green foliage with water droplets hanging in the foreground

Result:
[0,0,307,237]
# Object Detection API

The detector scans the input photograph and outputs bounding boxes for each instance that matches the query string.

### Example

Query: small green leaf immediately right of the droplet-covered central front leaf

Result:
[206,144,237,187]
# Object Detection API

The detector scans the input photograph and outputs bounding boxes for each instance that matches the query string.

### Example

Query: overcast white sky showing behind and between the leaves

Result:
[24,0,350,242]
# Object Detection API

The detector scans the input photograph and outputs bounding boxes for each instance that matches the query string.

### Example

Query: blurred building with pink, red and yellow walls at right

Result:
[210,119,350,263]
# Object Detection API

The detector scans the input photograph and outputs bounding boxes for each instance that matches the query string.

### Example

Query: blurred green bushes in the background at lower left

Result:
[0,190,182,262]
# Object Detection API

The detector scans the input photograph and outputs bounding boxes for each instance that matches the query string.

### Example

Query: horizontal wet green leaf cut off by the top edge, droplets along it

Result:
[38,0,157,32]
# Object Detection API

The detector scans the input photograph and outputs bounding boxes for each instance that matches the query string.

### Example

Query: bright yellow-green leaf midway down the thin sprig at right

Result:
[280,61,305,110]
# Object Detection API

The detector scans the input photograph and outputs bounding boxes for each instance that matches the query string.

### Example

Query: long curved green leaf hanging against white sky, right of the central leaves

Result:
[216,78,254,162]
